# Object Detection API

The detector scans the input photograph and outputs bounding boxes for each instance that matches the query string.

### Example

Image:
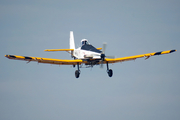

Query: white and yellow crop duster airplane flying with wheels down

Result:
[5,31,176,78]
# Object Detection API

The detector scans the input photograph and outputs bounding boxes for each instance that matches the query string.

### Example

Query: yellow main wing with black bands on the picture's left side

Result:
[5,55,85,65]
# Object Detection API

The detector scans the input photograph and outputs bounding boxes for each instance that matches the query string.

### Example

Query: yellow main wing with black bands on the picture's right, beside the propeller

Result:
[105,50,177,63]
